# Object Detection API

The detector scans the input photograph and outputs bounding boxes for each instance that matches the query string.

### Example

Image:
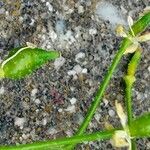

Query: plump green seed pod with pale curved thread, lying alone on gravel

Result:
[0,47,60,79]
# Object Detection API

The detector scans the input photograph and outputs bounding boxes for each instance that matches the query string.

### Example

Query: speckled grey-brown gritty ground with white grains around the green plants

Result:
[0,0,150,150]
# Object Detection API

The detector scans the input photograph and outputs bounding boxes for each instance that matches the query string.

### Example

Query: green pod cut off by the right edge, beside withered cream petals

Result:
[129,113,150,138]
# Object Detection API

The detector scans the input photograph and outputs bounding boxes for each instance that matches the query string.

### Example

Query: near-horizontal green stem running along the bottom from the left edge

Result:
[0,129,116,150]
